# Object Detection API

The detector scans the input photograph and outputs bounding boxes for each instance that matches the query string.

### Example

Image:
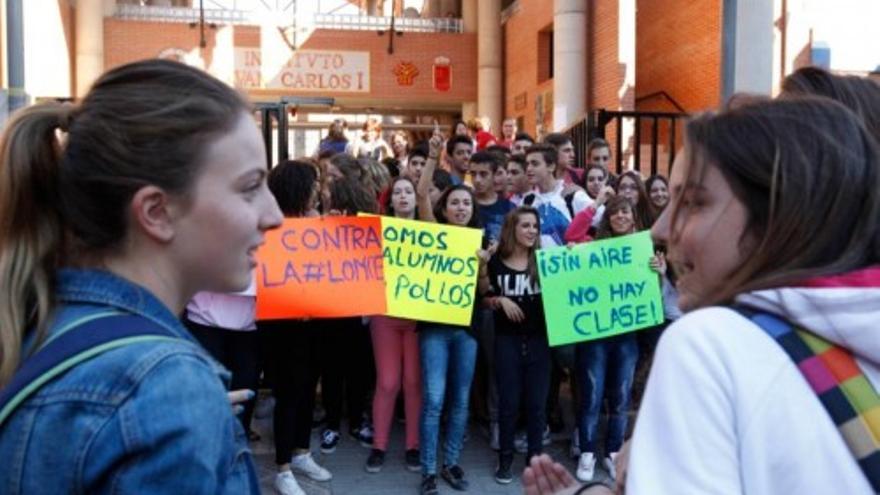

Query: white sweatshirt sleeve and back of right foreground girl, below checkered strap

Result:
[626,308,876,495]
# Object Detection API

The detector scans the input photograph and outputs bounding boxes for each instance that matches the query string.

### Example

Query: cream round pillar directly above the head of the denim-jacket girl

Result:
[75,0,106,98]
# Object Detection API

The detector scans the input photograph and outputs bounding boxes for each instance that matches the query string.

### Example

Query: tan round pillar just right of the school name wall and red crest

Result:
[477,0,504,133]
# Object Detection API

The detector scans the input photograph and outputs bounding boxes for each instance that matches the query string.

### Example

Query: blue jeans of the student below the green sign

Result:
[575,333,639,455]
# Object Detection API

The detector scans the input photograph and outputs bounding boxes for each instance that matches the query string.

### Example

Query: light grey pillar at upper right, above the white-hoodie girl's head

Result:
[721,0,775,100]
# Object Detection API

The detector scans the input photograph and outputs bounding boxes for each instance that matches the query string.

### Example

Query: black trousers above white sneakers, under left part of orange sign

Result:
[258,320,321,465]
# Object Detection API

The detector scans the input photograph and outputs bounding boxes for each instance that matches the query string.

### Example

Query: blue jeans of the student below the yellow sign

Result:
[419,326,477,474]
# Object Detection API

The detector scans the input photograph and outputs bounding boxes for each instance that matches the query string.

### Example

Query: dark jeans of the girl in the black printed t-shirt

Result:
[495,335,551,458]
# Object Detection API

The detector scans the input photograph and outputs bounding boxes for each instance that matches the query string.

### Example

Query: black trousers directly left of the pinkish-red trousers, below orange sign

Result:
[316,316,376,431]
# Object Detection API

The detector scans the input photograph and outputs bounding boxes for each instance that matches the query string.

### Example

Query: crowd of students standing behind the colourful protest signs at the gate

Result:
[188,109,674,494]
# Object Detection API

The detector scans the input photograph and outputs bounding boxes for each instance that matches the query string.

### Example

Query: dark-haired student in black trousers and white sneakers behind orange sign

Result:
[258,160,332,495]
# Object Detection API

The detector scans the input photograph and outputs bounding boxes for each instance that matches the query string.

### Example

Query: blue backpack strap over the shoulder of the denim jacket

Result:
[0,314,180,426]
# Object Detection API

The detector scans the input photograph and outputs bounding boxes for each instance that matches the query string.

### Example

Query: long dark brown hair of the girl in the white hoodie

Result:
[671,97,880,306]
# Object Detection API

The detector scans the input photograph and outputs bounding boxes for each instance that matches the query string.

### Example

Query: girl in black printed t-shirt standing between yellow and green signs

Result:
[480,206,551,484]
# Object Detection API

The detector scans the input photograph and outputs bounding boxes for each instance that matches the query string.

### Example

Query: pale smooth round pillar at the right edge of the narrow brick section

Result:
[553,0,587,131]
